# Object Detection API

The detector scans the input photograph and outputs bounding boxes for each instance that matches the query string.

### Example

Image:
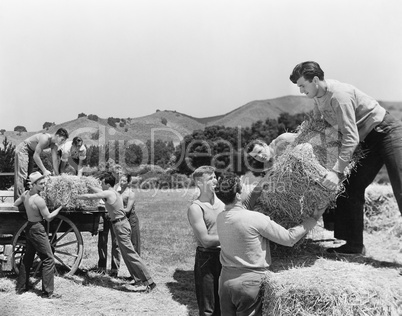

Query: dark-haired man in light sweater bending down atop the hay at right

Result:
[290,61,402,255]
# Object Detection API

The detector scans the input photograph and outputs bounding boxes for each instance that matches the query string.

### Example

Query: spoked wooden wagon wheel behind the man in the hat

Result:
[12,215,84,277]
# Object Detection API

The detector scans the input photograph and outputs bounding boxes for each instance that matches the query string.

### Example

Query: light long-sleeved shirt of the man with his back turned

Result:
[217,206,317,273]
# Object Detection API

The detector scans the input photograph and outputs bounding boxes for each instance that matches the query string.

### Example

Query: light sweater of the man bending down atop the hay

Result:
[314,79,386,173]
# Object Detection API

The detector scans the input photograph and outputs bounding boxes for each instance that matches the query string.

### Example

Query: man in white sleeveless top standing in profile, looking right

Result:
[187,166,225,316]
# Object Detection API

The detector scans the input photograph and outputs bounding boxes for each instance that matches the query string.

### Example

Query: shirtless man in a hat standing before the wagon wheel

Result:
[14,171,62,298]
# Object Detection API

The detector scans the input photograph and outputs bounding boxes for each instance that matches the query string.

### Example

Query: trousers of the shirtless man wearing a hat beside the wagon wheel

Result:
[17,222,55,294]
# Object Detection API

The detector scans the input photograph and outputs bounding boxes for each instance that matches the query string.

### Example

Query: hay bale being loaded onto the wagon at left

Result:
[41,174,101,209]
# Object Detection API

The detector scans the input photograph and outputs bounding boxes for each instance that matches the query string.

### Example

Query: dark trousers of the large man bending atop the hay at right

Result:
[334,113,402,248]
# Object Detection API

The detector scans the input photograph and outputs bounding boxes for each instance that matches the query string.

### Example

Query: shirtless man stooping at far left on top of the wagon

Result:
[14,128,68,200]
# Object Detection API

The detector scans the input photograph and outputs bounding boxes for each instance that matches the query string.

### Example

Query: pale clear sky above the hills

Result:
[0,0,402,131]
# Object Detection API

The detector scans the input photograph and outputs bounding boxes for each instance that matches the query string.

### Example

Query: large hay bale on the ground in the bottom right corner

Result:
[263,259,402,316]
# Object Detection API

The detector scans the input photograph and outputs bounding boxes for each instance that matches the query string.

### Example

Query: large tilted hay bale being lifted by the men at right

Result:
[255,119,361,228]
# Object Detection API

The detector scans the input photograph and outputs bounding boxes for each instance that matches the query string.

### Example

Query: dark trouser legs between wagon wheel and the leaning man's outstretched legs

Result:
[98,216,121,272]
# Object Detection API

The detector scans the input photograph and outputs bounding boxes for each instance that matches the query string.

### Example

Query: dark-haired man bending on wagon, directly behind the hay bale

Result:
[58,136,87,177]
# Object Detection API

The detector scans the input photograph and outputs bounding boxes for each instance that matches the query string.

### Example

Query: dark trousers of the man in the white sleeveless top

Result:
[194,247,222,316]
